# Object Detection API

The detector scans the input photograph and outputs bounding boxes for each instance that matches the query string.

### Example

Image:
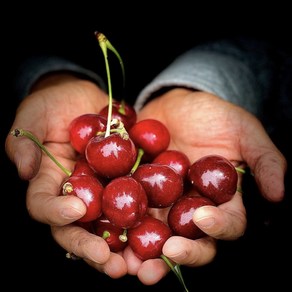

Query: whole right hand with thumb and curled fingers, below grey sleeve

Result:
[124,89,286,284]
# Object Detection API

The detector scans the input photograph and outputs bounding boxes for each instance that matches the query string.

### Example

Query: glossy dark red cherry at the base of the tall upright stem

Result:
[85,133,137,178]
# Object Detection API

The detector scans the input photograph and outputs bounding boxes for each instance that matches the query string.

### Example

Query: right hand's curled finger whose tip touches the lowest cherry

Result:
[162,236,216,267]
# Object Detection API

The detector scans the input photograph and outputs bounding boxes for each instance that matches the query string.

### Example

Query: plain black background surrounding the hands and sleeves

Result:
[0,1,292,291]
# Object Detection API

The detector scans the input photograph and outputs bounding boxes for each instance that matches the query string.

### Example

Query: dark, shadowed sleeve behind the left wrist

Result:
[14,55,106,99]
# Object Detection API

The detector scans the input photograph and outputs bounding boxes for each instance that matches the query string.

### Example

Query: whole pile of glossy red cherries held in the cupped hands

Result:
[62,101,238,260]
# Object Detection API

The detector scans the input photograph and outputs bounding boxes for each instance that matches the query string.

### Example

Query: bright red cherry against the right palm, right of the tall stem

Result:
[129,119,170,159]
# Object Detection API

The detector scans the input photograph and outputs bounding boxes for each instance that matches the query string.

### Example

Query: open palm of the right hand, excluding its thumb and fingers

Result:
[139,90,253,162]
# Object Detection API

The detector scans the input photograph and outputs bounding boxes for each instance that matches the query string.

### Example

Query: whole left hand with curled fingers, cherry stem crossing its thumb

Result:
[6,74,127,278]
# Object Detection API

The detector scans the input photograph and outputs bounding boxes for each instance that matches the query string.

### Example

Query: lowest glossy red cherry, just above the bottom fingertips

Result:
[128,216,172,261]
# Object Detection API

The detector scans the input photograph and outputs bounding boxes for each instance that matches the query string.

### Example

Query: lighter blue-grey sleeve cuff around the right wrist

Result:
[135,41,273,115]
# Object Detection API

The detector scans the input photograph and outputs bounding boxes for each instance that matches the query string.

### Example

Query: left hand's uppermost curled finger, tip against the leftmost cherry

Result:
[26,166,86,226]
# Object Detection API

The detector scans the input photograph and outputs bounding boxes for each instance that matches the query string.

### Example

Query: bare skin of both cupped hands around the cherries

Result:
[6,75,286,285]
